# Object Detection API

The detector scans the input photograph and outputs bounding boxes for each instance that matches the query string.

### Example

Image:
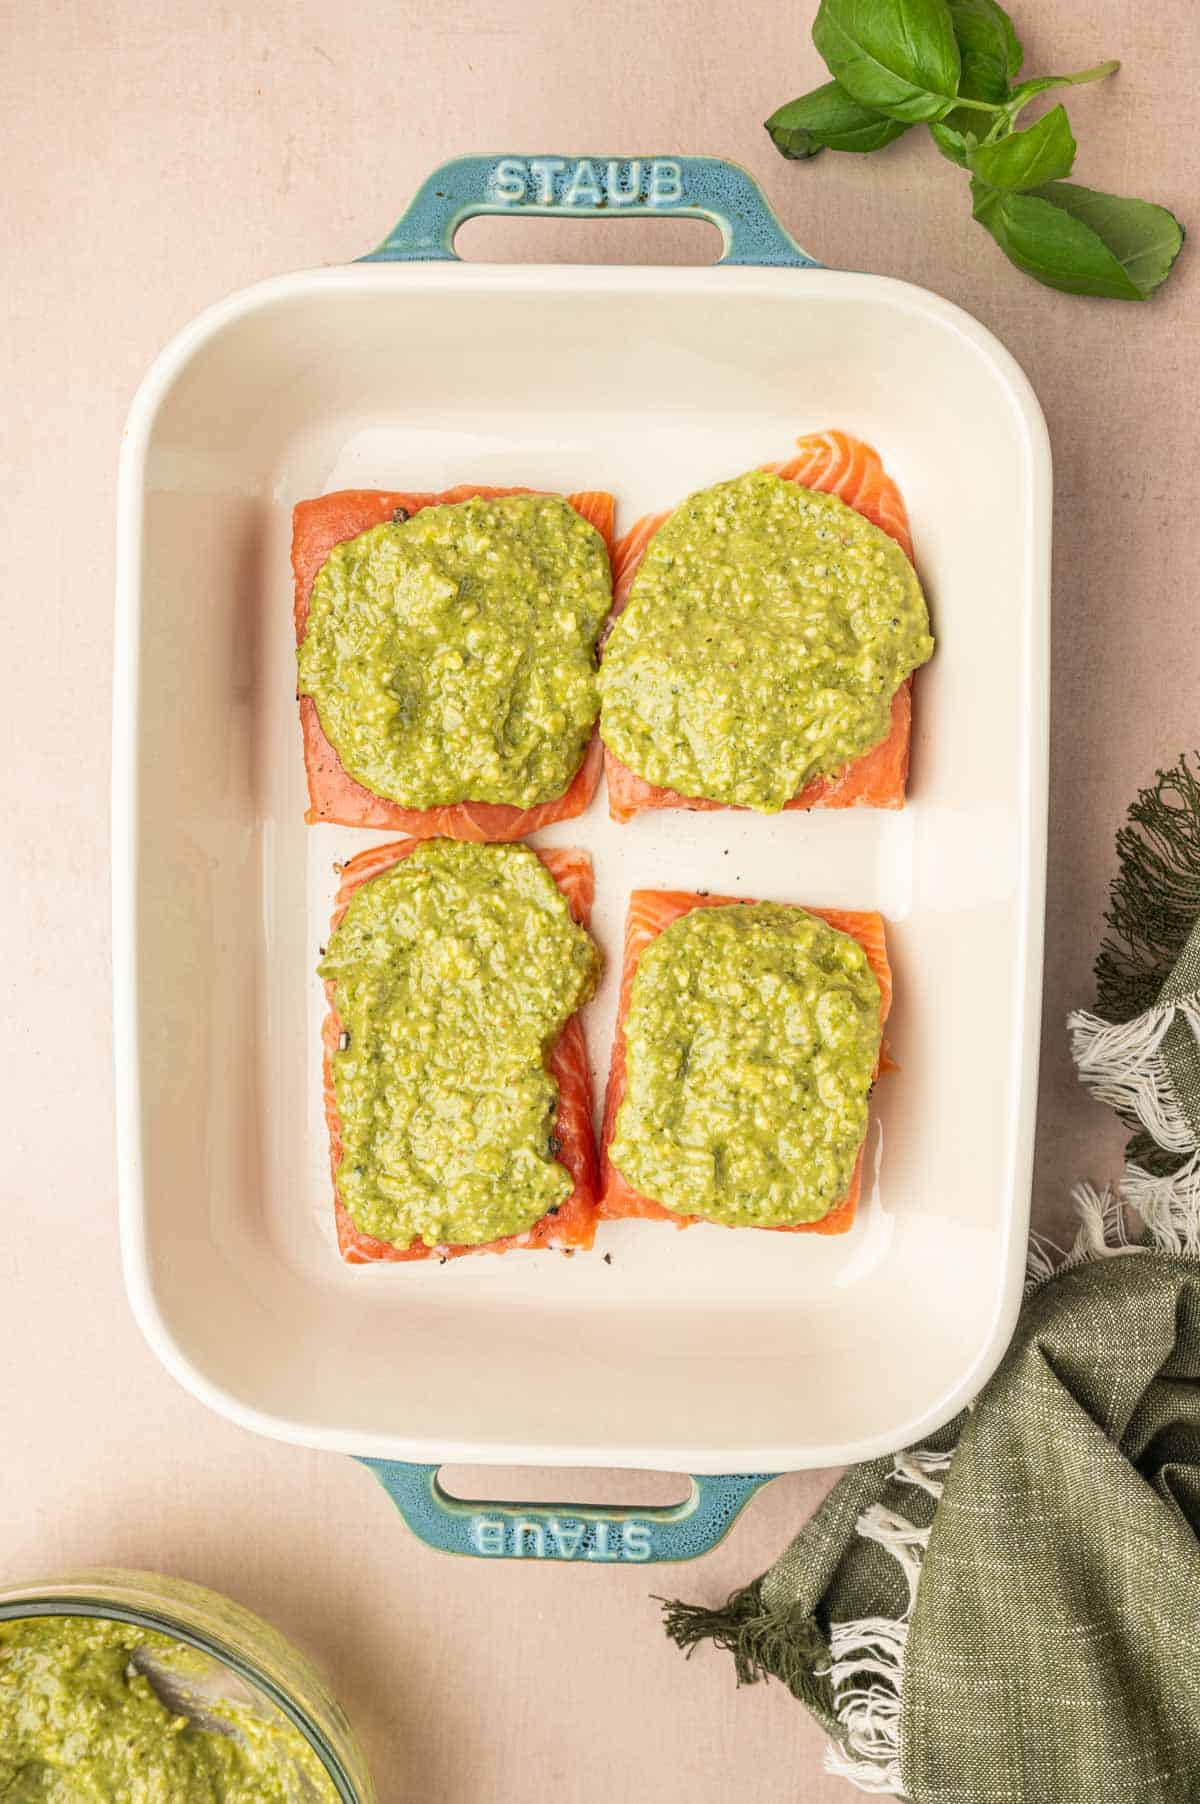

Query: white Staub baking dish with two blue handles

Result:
[114,159,1050,1559]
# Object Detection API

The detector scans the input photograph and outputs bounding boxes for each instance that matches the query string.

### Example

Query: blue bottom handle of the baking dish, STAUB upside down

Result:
[361,1459,776,1566]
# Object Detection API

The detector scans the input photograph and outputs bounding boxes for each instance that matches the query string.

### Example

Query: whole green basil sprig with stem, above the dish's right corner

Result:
[767,0,1184,301]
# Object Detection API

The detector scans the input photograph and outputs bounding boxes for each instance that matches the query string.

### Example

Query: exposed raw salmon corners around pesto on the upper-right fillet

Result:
[605,433,913,821]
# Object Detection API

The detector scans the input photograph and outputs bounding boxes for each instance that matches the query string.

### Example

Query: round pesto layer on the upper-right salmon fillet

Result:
[601,471,933,814]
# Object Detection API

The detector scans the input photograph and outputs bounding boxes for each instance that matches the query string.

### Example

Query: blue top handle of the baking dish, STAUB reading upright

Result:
[359,157,821,269]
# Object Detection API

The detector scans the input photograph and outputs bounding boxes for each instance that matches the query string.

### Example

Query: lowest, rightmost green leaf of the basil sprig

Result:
[971,177,1184,301]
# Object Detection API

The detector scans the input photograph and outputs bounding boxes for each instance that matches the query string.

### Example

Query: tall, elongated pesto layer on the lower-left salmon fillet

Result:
[319,839,599,1247]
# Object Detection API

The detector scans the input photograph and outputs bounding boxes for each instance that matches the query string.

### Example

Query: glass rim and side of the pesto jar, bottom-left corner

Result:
[0,1568,375,1804]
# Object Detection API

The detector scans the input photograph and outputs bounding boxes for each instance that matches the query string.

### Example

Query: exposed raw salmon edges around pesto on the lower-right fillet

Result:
[599,889,891,1234]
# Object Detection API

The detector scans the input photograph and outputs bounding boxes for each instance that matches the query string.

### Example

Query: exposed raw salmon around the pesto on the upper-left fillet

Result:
[292,483,614,841]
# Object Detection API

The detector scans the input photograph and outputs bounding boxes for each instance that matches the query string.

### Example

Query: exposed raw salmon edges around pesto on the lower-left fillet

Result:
[321,837,599,1265]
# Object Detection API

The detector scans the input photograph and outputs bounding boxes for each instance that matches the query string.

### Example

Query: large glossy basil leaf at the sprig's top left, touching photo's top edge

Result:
[812,0,960,124]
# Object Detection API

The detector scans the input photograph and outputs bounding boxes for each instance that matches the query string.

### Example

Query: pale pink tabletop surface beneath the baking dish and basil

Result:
[0,0,1200,1804]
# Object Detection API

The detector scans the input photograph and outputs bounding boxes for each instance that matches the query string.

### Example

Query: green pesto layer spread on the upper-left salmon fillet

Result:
[298,494,612,808]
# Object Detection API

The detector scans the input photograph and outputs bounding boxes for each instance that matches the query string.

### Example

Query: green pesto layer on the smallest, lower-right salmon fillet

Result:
[610,902,881,1229]
